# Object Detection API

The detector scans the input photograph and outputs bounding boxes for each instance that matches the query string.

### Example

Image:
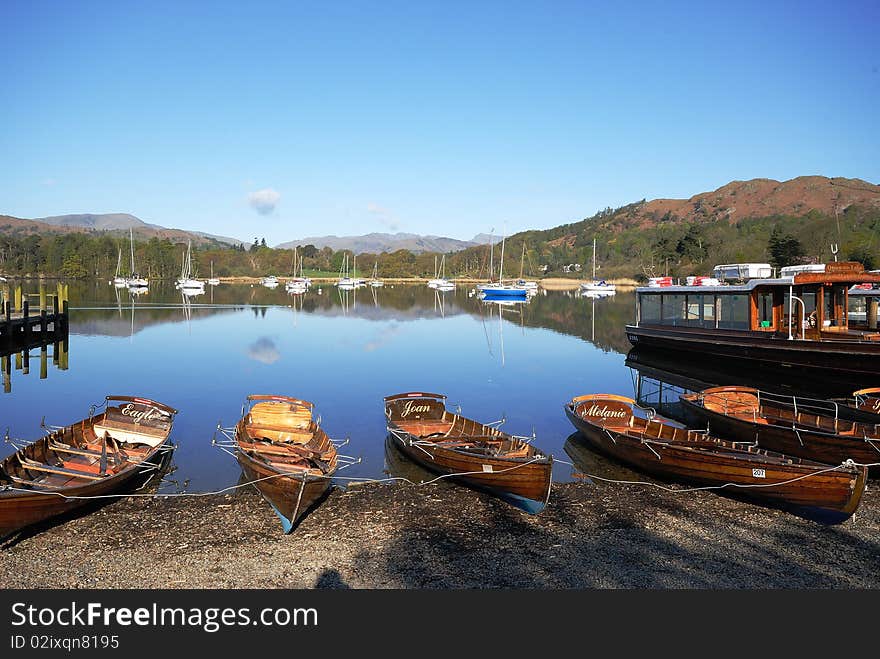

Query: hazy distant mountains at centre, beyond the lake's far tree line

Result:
[276,233,501,254]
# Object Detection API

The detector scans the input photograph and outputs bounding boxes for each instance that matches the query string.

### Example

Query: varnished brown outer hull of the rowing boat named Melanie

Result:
[565,405,867,524]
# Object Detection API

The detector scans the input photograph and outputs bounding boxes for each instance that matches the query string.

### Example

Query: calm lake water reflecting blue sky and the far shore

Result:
[0,282,634,492]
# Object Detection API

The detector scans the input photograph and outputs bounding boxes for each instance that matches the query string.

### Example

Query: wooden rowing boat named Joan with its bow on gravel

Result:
[385,392,553,512]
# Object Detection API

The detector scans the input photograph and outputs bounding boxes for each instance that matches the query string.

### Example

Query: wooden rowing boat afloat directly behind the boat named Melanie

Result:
[679,387,880,474]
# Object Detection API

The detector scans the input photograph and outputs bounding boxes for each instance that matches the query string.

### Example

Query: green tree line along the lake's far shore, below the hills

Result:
[0,205,880,281]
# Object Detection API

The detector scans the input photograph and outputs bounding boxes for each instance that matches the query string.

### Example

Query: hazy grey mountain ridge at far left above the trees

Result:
[0,213,242,246]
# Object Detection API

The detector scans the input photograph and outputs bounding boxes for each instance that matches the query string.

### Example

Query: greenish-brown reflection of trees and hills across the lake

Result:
[70,282,633,353]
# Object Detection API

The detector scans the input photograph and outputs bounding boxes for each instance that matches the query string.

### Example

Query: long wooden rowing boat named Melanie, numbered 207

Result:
[565,394,867,523]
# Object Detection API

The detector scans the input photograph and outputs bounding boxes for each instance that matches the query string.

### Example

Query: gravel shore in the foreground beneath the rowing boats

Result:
[0,474,880,589]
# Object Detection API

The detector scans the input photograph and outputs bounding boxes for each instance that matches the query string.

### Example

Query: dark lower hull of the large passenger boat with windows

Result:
[626,325,880,382]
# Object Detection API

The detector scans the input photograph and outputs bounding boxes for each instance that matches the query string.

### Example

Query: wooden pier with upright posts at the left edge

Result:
[0,283,68,393]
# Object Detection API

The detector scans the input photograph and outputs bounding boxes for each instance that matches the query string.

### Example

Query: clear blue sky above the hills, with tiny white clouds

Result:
[0,0,880,244]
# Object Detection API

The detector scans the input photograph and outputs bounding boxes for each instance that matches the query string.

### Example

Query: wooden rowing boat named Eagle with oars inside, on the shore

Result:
[0,396,177,537]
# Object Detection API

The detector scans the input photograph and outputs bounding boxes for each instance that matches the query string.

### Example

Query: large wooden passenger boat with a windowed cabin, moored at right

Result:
[626,262,880,376]
